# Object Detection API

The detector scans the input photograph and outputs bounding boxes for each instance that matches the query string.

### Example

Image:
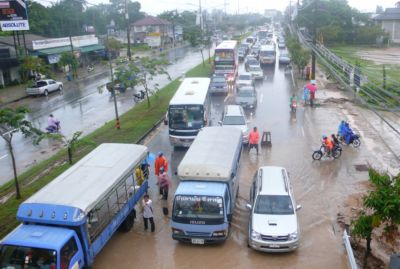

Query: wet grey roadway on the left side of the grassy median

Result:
[0,47,212,185]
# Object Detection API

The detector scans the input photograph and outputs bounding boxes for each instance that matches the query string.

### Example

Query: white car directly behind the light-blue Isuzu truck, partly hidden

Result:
[219,105,249,145]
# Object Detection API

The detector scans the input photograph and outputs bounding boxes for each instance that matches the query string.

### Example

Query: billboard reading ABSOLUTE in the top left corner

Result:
[0,0,29,31]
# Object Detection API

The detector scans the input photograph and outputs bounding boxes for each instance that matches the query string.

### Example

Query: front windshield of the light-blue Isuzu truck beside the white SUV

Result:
[172,195,224,224]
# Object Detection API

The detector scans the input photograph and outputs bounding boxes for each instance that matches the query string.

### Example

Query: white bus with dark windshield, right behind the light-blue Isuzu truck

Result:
[167,78,211,147]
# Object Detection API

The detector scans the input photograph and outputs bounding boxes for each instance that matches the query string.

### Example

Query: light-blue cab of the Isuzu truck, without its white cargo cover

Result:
[172,181,234,244]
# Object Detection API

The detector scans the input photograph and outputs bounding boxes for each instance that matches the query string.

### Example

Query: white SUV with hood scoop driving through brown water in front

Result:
[246,166,301,252]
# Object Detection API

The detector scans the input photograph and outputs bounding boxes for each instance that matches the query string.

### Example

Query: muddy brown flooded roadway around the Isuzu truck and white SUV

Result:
[90,47,400,269]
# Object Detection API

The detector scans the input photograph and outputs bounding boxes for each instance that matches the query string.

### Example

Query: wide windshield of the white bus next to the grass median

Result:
[169,105,204,130]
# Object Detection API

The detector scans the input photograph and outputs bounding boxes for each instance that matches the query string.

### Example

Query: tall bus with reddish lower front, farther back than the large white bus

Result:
[213,40,239,78]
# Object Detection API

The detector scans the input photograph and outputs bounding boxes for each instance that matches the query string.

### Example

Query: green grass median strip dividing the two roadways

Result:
[0,61,211,238]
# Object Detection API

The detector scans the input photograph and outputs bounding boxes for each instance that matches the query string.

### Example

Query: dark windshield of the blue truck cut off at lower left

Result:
[0,245,57,269]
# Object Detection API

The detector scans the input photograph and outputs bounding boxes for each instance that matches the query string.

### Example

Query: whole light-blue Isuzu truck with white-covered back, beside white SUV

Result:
[171,126,242,244]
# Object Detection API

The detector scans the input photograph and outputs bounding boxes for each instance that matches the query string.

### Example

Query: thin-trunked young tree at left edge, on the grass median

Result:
[0,107,40,199]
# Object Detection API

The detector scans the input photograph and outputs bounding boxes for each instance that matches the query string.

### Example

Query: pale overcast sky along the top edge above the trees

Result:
[36,0,398,15]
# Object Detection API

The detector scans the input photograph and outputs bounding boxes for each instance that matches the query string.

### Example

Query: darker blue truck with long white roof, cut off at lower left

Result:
[0,143,148,269]
